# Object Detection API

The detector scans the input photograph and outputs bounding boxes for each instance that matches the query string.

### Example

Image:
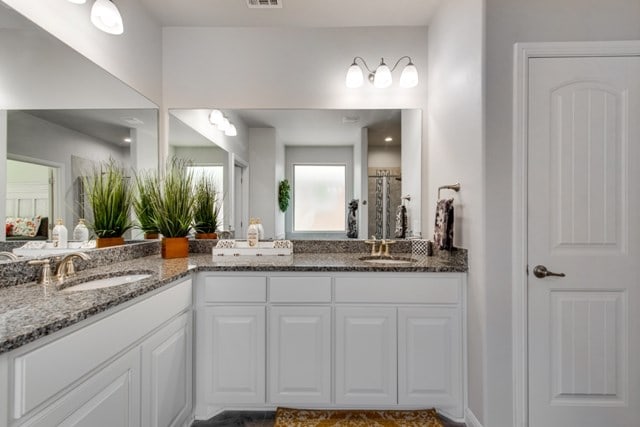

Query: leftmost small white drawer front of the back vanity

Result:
[204,276,267,302]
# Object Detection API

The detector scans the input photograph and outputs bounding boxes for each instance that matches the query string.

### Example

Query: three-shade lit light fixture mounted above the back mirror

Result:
[345,56,418,88]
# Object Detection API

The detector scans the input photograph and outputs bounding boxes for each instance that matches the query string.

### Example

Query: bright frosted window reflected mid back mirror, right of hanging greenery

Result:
[293,165,346,231]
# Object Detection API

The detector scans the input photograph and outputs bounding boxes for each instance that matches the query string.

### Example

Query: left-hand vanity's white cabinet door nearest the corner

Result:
[142,313,192,427]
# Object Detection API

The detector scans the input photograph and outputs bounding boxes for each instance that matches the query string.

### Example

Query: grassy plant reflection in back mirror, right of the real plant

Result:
[193,176,220,239]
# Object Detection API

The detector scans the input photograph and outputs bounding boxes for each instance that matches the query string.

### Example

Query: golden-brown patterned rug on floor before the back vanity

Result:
[274,408,443,427]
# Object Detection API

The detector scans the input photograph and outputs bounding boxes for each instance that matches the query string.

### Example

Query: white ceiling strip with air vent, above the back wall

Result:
[141,0,442,28]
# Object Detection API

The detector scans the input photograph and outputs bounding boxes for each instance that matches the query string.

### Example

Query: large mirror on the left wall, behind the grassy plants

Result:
[0,6,158,260]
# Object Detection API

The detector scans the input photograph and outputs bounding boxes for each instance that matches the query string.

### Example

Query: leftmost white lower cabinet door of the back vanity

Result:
[203,306,266,404]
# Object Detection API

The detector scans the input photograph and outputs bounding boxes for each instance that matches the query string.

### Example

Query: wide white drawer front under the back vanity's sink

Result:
[336,275,460,304]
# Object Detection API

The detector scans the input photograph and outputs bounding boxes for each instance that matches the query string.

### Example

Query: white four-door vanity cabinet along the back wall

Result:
[195,272,466,419]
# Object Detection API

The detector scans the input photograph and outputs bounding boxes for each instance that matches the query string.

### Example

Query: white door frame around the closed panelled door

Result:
[511,40,640,427]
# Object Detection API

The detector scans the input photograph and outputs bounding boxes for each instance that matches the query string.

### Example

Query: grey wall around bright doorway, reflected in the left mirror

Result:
[3,111,129,230]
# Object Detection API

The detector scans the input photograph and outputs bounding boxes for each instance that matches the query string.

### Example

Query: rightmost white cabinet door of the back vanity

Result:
[398,308,462,416]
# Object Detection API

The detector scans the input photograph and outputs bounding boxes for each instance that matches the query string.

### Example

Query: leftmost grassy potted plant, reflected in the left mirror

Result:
[84,159,133,248]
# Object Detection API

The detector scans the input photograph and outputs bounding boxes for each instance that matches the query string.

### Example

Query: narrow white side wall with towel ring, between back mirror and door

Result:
[422,0,484,427]
